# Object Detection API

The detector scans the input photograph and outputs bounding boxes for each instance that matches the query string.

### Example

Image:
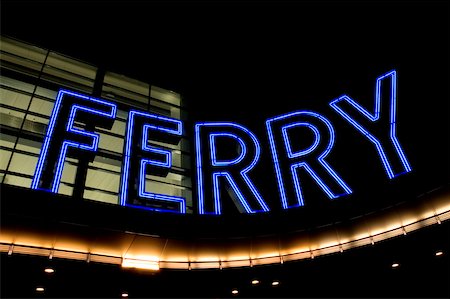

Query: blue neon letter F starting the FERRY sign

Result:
[31,90,117,193]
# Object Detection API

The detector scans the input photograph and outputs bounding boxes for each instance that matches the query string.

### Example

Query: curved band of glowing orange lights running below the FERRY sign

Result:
[0,192,450,272]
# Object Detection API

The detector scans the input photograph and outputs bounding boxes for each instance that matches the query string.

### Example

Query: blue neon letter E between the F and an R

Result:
[119,110,186,213]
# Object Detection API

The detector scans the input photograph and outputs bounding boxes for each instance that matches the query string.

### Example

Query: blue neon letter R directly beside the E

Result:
[195,122,269,215]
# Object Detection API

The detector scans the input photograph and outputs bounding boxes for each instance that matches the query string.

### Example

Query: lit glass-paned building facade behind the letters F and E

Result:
[0,37,193,213]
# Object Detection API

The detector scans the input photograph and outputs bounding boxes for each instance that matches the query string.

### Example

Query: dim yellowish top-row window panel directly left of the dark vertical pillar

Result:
[46,52,97,82]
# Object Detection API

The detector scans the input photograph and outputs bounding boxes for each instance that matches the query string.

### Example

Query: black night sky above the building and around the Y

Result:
[2,1,450,219]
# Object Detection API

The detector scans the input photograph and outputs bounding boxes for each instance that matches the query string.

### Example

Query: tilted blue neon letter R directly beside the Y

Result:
[266,111,352,209]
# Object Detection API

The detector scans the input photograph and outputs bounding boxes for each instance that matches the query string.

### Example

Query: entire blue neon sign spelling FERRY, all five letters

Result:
[31,71,411,215]
